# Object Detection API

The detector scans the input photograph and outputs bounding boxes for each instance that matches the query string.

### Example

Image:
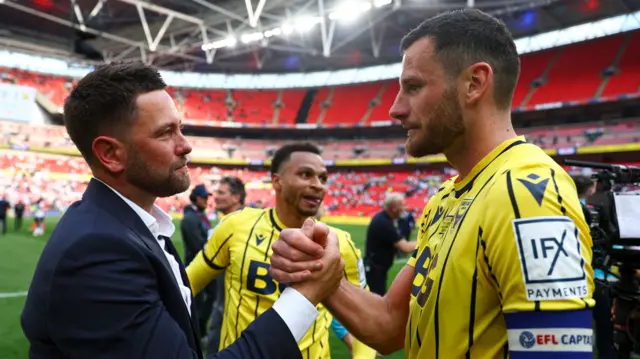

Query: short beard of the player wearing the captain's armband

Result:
[406,86,465,158]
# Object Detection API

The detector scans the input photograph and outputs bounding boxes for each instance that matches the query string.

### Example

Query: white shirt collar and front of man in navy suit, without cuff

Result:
[94,177,192,315]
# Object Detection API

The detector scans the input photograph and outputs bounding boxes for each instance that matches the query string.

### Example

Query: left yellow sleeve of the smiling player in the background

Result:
[187,220,234,296]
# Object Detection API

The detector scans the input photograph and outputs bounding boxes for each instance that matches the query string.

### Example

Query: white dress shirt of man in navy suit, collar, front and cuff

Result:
[94,177,319,342]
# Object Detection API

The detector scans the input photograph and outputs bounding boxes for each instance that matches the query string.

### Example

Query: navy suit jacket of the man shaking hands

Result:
[21,179,302,359]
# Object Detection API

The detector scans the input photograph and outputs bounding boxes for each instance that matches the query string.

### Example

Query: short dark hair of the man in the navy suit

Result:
[64,62,167,163]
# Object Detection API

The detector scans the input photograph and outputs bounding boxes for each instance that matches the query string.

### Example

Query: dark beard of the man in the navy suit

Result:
[125,149,191,197]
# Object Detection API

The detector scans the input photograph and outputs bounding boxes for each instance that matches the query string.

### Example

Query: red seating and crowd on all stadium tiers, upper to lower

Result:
[0,32,640,221]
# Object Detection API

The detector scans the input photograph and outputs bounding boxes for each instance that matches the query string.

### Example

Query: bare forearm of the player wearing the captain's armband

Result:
[323,279,409,354]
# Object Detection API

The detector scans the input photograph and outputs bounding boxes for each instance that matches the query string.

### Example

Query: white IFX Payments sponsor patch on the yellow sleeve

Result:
[513,216,588,301]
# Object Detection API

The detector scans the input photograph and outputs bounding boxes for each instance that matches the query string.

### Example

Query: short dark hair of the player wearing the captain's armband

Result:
[400,9,520,109]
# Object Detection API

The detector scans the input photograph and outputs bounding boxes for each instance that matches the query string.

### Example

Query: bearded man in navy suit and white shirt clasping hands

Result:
[22,63,344,359]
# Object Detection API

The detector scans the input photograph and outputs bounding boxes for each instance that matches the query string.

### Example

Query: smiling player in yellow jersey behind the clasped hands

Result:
[187,144,376,359]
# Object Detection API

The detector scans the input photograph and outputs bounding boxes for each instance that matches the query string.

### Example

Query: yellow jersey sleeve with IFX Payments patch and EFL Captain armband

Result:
[478,163,594,359]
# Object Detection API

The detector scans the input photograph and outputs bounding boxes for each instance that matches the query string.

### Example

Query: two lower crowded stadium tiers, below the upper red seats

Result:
[0,110,640,217]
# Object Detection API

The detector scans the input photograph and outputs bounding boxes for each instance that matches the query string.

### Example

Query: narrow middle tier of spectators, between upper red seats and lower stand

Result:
[0,119,640,160]
